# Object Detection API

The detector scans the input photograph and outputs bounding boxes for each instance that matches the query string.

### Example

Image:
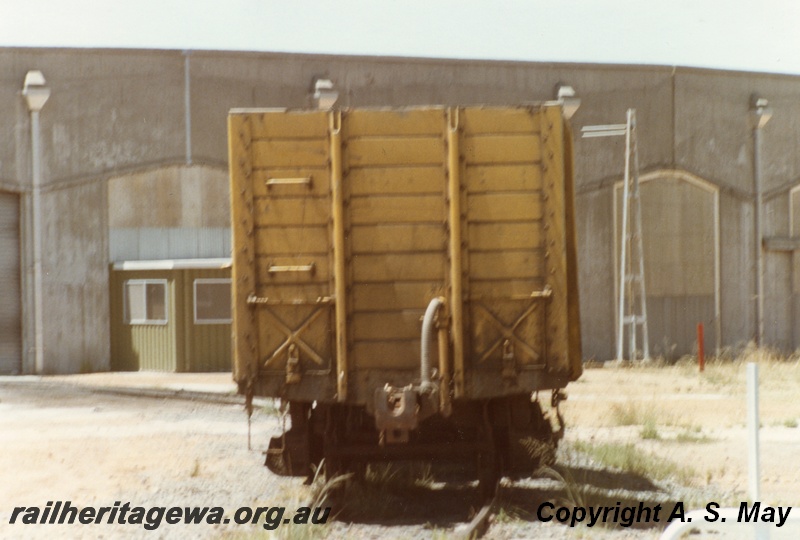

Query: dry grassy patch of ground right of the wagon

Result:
[563,346,800,501]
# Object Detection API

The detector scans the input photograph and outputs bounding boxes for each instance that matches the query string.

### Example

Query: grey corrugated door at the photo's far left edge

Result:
[0,193,22,373]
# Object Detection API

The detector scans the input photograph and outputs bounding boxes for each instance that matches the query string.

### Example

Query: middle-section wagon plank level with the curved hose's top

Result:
[352,280,444,311]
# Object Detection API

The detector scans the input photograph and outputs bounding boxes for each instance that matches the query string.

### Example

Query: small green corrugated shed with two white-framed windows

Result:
[109,259,231,372]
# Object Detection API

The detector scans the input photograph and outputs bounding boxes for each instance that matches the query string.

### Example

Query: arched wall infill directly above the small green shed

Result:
[108,166,231,262]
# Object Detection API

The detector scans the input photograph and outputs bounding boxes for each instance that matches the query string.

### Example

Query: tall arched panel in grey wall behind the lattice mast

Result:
[614,171,721,360]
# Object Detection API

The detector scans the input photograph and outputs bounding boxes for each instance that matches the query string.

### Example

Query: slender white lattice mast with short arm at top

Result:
[581,109,650,362]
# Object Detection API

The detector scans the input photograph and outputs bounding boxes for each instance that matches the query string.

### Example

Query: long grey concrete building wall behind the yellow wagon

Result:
[0,49,800,372]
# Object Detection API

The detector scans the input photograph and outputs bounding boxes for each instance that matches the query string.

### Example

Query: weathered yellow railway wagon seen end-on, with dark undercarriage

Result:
[228,105,581,479]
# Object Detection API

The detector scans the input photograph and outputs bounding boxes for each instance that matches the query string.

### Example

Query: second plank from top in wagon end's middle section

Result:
[345,137,445,168]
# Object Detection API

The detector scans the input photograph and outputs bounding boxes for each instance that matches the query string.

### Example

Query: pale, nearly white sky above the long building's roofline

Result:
[0,0,800,75]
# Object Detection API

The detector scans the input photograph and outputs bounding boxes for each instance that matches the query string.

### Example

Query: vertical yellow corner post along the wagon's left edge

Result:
[228,115,258,383]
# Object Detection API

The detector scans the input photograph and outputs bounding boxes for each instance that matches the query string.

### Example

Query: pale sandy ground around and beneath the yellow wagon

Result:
[0,359,800,539]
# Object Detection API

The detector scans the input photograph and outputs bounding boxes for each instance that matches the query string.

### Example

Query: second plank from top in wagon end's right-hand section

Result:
[462,135,542,166]
